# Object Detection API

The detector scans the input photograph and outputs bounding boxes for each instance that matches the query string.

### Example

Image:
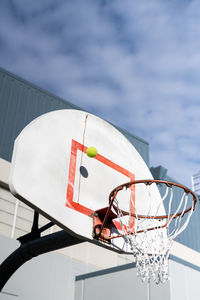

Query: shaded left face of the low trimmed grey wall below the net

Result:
[75,264,170,300]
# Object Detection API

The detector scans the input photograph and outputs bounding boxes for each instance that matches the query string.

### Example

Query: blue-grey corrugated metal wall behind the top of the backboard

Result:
[0,68,149,164]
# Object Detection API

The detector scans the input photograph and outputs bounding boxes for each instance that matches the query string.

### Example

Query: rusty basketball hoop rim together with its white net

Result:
[96,179,197,283]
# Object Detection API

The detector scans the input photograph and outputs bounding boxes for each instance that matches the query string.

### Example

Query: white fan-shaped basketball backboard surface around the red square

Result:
[10,110,163,250]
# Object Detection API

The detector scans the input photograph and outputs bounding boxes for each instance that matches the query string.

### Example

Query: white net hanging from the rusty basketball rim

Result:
[113,183,195,283]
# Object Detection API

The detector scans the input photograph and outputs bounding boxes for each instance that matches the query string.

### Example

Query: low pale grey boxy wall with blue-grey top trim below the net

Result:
[75,257,200,300]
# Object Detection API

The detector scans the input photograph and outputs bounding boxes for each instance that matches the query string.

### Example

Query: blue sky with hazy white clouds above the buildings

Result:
[0,0,200,186]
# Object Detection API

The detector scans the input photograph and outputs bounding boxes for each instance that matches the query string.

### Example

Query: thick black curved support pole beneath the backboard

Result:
[0,230,85,291]
